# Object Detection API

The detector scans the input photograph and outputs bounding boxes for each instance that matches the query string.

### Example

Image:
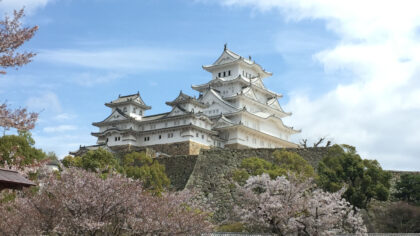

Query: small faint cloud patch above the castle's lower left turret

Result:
[26,92,61,113]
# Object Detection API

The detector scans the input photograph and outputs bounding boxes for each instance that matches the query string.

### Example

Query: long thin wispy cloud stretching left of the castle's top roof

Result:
[37,47,208,72]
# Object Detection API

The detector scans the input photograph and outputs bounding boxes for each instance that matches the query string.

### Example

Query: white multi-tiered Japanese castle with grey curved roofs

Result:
[72,45,300,155]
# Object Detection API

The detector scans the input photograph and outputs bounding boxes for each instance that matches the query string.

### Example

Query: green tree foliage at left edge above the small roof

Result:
[0,135,46,167]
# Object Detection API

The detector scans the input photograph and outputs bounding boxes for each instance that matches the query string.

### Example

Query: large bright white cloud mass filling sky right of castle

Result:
[220,0,420,170]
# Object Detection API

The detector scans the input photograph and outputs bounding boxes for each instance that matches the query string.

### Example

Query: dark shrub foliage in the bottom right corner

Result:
[369,201,420,233]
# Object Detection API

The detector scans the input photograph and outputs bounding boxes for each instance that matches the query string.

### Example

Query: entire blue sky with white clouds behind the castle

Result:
[0,0,420,171]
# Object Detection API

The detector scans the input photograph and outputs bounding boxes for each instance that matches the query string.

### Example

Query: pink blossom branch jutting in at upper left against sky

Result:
[0,9,38,74]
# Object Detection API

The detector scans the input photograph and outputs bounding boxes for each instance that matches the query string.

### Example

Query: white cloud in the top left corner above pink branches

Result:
[0,0,54,14]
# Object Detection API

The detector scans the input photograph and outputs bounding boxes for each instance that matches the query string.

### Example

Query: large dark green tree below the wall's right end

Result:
[318,145,391,208]
